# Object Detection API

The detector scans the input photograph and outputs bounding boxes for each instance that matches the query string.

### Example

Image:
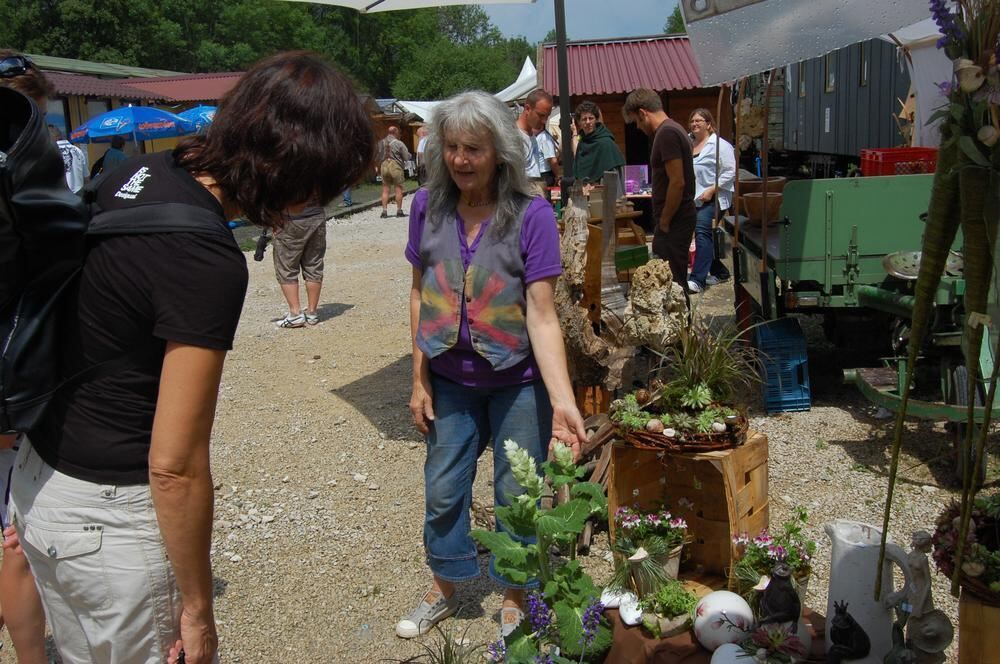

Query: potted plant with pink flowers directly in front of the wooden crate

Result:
[608,506,687,598]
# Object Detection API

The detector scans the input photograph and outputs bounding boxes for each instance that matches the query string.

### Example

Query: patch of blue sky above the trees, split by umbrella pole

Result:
[483,0,677,42]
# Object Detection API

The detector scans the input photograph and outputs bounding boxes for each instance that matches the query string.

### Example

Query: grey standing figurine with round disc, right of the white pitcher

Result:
[903,530,955,664]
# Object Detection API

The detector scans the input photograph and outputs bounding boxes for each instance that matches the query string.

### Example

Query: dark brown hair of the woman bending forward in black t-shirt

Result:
[174,51,375,228]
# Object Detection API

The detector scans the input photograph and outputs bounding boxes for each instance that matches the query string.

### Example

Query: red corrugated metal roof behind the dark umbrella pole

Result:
[542,37,703,97]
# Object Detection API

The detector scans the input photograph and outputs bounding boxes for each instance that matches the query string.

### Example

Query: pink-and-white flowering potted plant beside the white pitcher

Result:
[729,506,816,606]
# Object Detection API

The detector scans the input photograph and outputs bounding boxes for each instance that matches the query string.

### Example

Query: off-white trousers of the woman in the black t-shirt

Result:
[10,439,193,664]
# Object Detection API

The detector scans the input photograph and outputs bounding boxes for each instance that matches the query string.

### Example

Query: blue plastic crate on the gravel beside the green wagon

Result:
[754,318,812,413]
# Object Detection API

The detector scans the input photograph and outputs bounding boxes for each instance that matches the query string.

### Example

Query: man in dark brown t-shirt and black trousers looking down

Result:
[622,88,697,290]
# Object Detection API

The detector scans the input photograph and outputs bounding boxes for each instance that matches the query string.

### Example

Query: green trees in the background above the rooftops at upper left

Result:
[0,0,535,99]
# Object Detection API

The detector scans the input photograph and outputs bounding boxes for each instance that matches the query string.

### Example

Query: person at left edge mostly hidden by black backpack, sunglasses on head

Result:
[0,49,53,664]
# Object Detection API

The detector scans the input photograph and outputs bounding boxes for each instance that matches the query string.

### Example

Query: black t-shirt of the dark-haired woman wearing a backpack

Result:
[31,153,248,484]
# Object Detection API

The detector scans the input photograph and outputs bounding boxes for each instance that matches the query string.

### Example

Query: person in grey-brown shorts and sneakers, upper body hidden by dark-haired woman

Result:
[274,202,326,327]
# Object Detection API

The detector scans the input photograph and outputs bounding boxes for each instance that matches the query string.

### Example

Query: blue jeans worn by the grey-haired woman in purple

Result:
[424,374,552,588]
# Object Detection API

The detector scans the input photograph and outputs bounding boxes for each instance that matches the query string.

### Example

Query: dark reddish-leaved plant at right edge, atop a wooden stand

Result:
[931,493,1000,605]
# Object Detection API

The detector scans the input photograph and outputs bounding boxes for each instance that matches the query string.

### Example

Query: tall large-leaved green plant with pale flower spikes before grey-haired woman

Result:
[472,440,611,664]
